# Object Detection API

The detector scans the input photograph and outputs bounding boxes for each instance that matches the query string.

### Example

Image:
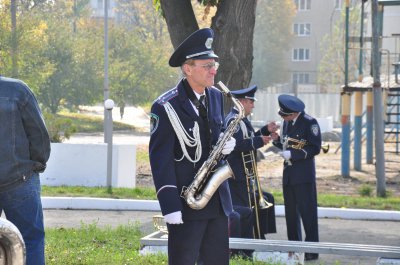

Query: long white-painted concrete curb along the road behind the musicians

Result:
[42,197,400,221]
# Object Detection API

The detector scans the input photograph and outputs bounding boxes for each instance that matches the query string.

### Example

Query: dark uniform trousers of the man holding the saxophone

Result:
[168,214,229,265]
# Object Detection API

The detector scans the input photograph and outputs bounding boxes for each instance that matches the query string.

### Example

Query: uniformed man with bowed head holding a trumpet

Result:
[273,94,321,260]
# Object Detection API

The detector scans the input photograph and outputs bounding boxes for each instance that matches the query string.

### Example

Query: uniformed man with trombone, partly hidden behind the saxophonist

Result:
[225,86,278,239]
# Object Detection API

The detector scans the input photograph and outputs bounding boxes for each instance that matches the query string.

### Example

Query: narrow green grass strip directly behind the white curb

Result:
[42,186,400,211]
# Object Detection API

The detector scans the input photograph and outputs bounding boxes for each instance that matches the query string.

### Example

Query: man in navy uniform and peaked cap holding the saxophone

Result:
[149,28,235,265]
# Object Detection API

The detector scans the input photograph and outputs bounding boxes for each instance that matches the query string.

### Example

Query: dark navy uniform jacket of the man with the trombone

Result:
[225,108,269,207]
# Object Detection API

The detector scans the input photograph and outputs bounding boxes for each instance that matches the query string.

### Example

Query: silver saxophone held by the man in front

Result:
[182,81,244,210]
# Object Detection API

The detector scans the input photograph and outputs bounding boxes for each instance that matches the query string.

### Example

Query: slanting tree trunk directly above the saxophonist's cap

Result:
[160,0,199,49]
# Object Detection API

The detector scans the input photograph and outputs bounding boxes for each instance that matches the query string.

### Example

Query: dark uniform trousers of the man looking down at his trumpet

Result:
[283,182,319,242]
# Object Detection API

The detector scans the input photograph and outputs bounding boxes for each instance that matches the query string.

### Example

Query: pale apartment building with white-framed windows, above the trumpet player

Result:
[287,0,344,93]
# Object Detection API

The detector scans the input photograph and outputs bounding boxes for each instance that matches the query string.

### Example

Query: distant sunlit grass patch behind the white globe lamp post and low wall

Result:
[57,111,136,133]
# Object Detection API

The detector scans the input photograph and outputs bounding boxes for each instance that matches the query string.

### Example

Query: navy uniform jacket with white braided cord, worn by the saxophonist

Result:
[149,80,232,221]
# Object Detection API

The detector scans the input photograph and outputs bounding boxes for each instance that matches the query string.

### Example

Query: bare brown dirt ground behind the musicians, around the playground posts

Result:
[136,142,400,196]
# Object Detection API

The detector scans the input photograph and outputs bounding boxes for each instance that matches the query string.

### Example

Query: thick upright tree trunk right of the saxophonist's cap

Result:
[211,0,257,90]
